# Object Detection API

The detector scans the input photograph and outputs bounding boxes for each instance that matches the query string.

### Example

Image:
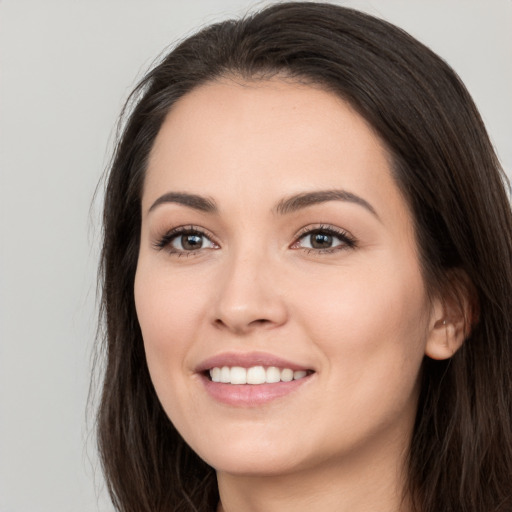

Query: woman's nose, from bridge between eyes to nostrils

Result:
[214,251,288,335]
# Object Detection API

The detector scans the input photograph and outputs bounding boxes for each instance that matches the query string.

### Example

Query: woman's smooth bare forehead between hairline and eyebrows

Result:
[143,79,408,224]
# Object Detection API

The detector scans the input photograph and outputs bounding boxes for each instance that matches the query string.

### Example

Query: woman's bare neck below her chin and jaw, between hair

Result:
[217,438,411,512]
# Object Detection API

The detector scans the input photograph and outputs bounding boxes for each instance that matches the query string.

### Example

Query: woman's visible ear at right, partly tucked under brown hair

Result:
[425,270,478,360]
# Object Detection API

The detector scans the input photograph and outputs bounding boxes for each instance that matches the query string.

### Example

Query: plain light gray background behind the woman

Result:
[0,0,512,512]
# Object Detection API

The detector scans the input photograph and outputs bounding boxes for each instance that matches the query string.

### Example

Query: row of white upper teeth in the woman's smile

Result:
[210,366,308,384]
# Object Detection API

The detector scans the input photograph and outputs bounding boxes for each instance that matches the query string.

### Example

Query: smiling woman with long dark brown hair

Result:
[98,2,512,512]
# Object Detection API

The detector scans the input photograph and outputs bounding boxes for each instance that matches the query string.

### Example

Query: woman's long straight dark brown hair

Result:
[97,2,512,512]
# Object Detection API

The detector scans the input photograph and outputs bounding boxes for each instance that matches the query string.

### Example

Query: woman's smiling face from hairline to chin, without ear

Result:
[135,79,434,474]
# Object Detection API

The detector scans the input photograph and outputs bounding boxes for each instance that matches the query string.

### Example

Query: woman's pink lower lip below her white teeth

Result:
[201,375,312,407]
